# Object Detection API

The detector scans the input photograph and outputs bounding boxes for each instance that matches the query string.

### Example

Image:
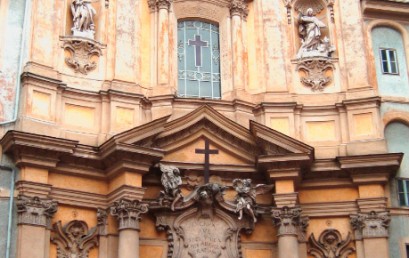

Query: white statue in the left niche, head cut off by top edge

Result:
[71,0,97,39]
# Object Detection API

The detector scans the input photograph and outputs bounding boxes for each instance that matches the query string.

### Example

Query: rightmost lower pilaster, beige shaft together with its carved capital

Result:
[351,211,390,258]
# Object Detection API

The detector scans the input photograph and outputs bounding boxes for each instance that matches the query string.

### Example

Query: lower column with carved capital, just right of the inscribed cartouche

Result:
[272,206,308,258]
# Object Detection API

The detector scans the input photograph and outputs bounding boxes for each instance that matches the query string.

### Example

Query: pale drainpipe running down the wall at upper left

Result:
[0,0,31,126]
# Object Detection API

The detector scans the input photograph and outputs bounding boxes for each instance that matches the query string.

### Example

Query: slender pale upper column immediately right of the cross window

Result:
[230,0,248,91]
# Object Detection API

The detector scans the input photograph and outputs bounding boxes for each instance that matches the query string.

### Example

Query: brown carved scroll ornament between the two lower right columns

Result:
[308,229,355,258]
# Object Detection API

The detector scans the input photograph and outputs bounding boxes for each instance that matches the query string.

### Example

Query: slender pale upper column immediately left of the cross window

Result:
[156,0,170,86]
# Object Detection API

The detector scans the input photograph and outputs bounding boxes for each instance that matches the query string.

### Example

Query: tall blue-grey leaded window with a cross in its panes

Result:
[177,20,220,99]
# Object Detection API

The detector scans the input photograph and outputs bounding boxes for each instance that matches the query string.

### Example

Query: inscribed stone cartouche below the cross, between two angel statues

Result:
[150,183,260,258]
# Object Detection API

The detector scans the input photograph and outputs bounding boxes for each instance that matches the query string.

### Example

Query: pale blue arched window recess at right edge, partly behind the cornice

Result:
[385,122,409,206]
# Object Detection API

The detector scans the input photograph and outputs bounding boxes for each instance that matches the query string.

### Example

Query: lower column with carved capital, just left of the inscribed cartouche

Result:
[111,199,148,258]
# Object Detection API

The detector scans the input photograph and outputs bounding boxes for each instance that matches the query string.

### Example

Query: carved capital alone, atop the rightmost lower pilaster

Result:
[350,211,390,240]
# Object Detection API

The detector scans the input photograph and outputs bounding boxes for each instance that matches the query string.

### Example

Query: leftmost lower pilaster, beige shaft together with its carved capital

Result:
[16,195,57,258]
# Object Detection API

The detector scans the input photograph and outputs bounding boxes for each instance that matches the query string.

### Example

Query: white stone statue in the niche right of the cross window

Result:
[297,8,335,59]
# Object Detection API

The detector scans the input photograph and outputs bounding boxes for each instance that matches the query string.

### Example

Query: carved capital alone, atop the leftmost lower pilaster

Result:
[17,195,57,228]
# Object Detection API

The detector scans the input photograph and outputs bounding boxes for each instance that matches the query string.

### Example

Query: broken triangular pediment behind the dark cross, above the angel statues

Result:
[107,105,313,168]
